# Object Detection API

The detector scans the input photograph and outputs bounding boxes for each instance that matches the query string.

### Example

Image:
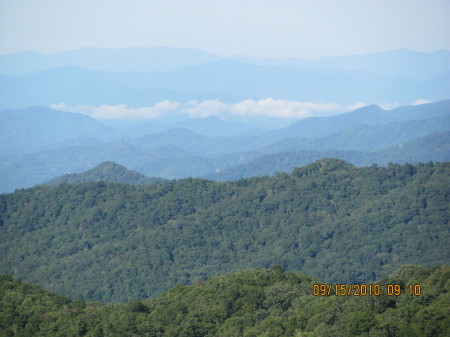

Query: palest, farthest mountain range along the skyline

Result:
[0,47,450,80]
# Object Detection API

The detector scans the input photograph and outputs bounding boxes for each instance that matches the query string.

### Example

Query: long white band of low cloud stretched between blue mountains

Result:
[51,98,342,119]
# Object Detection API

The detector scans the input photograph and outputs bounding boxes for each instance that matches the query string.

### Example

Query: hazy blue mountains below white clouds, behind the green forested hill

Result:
[0,101,450,192]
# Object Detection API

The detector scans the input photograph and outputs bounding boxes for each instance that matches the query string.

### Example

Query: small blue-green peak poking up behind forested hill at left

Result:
[47,162,166,186]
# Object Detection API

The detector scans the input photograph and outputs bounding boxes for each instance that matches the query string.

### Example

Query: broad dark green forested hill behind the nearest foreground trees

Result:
[0,159,450,302]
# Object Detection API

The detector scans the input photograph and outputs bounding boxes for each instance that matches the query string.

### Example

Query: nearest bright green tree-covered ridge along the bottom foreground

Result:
[0,265,450,337]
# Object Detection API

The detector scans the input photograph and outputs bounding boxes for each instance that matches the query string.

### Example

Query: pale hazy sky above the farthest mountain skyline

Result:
[0,0,450,58]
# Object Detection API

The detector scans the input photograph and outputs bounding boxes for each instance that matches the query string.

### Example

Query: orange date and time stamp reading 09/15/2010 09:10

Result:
[313,284,422,296]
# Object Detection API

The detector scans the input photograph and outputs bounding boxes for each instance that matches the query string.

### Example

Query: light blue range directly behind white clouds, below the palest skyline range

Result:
[0,60,450,108]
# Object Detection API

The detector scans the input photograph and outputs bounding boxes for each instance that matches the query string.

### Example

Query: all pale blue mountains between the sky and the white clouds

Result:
[0,47,450,109]
